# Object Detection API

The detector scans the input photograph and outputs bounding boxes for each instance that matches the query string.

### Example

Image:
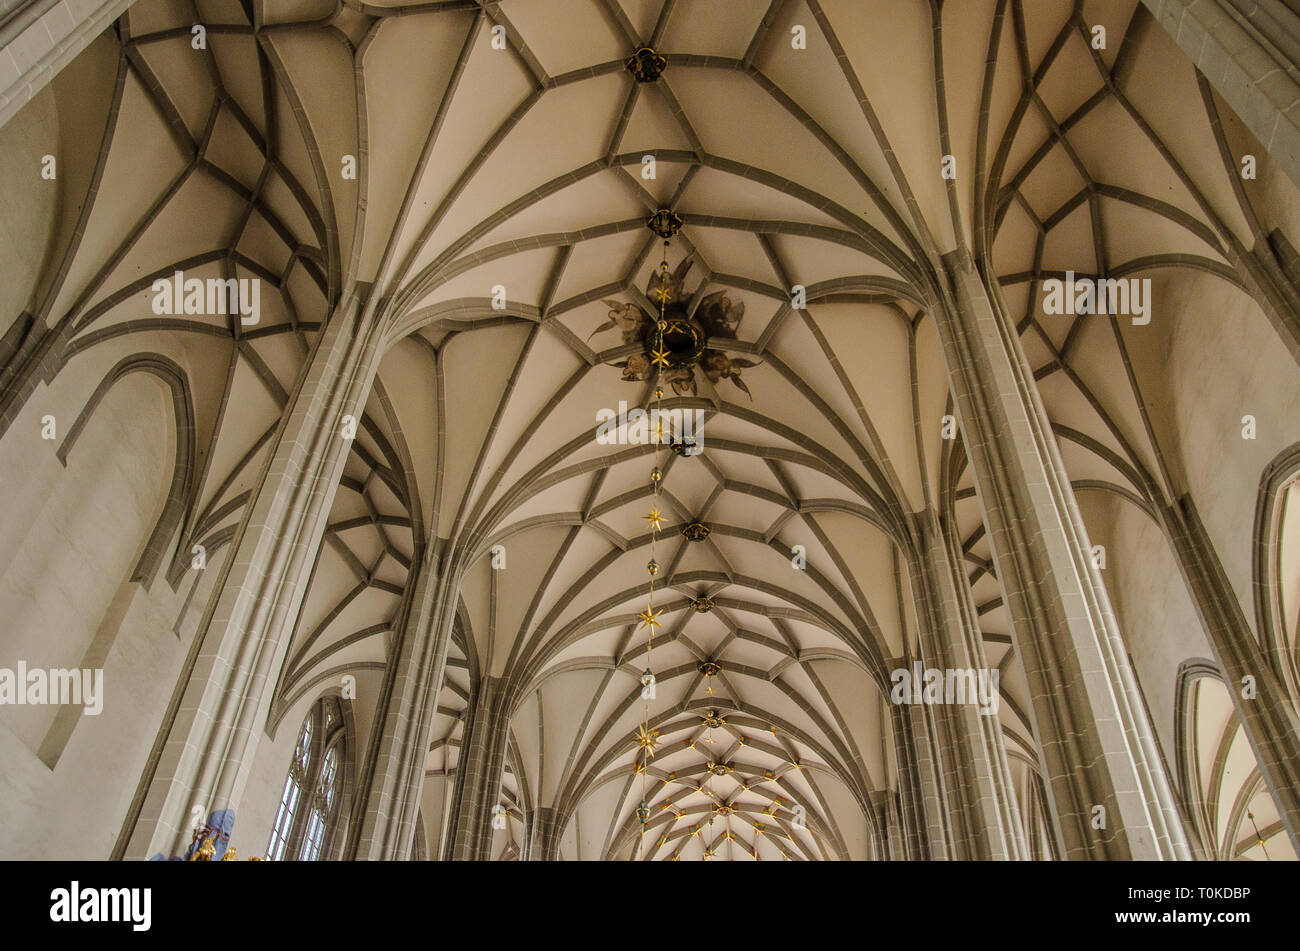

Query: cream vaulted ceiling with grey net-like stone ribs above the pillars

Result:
[14,0,1294,860]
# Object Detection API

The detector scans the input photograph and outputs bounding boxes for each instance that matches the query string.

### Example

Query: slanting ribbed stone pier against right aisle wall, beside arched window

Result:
[1161,496,1300,850]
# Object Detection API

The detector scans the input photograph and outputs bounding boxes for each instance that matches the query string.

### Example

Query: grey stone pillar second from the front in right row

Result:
[911,511,1027,860]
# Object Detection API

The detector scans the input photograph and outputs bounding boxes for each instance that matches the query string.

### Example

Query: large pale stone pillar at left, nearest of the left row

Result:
[113,290,377,859]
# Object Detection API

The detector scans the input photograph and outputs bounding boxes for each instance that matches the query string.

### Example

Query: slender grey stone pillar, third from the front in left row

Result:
[443,677,510,861]
